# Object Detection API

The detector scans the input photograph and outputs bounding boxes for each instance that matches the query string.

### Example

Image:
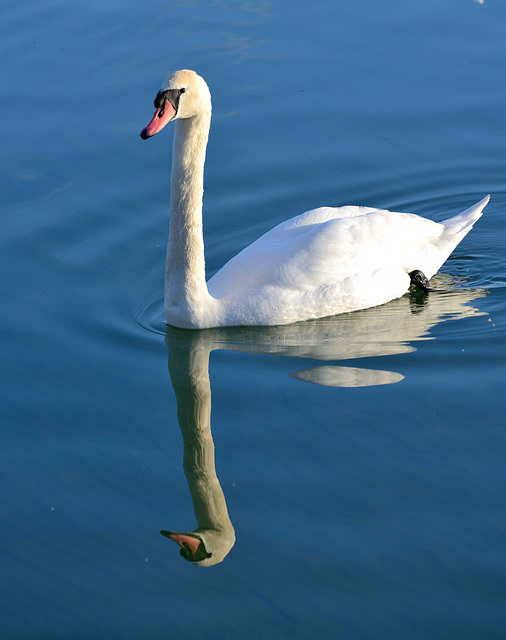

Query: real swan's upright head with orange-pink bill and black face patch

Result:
[141,69,211,140]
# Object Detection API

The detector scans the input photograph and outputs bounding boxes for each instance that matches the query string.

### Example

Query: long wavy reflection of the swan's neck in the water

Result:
[169,346,235,565]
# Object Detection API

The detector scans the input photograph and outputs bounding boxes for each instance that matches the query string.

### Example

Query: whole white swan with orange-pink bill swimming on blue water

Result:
[141,69,490,329]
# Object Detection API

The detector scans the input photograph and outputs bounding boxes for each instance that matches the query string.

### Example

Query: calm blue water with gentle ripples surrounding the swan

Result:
[0,0,506,640]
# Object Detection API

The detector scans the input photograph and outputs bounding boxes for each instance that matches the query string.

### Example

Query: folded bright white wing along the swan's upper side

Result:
[208,207,444,299]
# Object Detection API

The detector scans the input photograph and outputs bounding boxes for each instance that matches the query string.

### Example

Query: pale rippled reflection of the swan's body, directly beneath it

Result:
[166,276,485,386]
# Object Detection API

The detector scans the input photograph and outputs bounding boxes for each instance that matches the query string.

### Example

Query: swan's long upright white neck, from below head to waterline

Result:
[165,108,211,327]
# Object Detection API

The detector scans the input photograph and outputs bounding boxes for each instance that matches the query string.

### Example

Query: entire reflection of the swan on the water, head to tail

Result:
[161,280,485,566]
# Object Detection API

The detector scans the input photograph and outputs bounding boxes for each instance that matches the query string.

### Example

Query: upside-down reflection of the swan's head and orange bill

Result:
[160,525,235,567]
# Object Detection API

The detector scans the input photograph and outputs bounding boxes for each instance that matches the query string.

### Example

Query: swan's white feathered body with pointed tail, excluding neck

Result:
[208,198,488,324]
